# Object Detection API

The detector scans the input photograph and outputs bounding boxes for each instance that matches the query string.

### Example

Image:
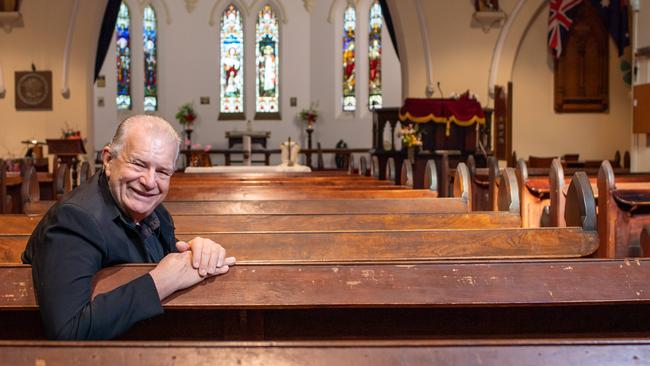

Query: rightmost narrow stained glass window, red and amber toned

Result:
[368,0,382,110]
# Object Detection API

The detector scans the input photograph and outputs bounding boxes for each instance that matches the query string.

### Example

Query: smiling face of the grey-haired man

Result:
[103,126,176,222]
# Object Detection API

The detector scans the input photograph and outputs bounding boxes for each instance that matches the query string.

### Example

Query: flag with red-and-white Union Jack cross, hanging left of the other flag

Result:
[548,0,580,58]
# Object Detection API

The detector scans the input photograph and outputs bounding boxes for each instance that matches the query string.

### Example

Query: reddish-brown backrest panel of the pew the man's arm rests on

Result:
[0,259,650,310]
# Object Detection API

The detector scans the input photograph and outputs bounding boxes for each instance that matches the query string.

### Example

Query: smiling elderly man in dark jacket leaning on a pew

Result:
[23,116,235,339]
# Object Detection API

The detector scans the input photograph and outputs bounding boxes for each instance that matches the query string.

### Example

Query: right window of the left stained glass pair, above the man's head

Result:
[142,5,158,112]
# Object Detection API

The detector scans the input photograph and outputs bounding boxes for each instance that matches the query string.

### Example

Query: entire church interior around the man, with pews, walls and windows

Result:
[0,0,650,365]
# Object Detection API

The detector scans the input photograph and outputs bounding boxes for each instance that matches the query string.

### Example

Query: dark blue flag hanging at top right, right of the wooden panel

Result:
[591,0,630,57]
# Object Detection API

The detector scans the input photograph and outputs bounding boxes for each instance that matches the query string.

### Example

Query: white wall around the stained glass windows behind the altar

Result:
[94,0,401,163]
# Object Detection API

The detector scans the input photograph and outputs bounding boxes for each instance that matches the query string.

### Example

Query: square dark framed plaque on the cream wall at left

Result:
[16,71,52,111]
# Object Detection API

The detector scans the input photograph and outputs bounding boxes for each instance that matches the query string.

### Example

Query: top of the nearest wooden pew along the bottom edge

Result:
[0,338,650,366]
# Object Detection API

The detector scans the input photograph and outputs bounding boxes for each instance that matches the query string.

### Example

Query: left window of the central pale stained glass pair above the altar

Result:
[220,4,244,113]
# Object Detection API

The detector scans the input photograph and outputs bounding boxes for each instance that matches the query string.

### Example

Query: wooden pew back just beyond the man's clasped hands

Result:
[0,224,598,263]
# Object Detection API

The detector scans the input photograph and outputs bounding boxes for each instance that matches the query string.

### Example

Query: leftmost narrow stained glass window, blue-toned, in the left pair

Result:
[115,2,131,109]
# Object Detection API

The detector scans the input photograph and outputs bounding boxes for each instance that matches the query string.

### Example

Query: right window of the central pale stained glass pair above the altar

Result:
[255,4,280,113]
